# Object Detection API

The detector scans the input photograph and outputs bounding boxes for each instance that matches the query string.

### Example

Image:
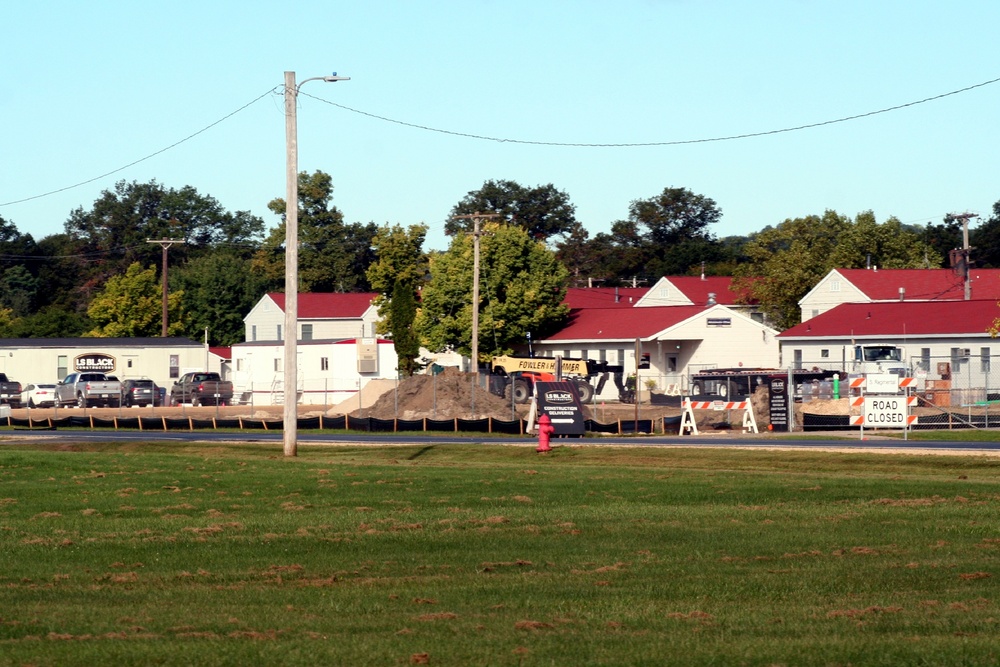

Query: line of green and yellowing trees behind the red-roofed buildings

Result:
[0,171,1000,360]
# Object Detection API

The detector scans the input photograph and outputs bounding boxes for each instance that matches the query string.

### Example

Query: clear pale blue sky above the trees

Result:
[0,0,1000,249]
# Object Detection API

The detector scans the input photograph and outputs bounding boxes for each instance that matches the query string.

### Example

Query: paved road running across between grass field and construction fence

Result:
[0,428,1000,455]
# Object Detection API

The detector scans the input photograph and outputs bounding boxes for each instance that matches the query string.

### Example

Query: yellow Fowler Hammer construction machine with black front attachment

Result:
[489,355,624,403]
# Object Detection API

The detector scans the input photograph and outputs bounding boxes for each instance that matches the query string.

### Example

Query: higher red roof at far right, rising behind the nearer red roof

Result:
[837,269,1000,301]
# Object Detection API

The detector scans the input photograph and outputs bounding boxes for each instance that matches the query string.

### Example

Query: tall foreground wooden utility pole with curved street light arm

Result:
[282,72,351,456]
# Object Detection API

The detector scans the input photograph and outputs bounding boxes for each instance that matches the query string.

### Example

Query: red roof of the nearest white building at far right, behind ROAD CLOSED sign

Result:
[778,300,1000,340]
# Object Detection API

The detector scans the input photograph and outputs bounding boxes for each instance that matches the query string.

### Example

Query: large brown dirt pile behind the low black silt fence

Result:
[351,367,517,421]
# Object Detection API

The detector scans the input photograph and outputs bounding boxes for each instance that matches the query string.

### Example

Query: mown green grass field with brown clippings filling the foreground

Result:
[0,443,1000,666]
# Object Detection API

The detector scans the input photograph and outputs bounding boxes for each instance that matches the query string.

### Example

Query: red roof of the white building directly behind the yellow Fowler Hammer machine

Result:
[545,306,708,343]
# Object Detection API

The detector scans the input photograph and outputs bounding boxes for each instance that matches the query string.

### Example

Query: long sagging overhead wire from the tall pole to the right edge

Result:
[302,77,1000,148]
